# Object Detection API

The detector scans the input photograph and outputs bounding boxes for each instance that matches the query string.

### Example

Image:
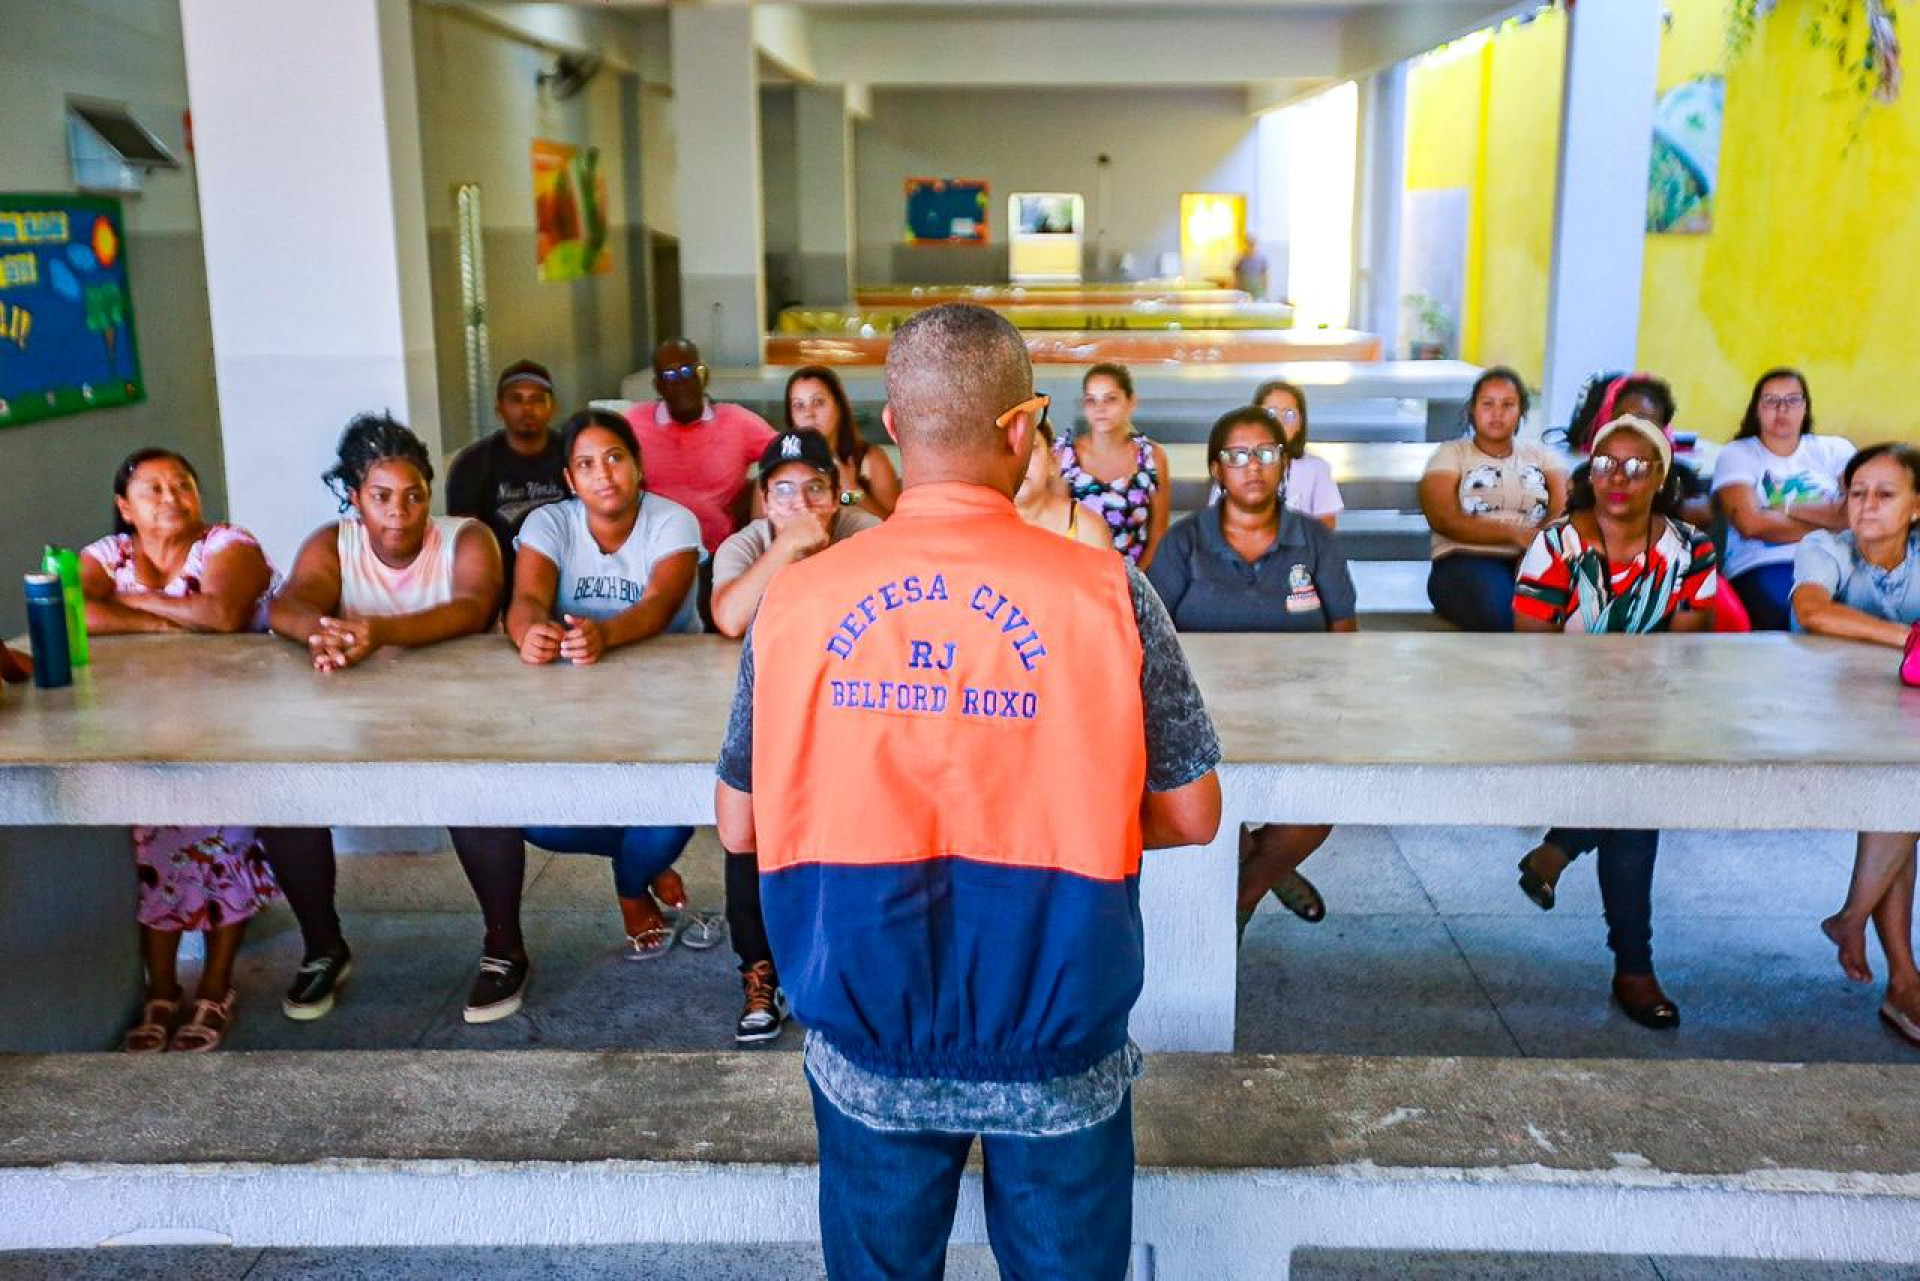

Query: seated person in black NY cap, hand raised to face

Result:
[712,430,879,1045]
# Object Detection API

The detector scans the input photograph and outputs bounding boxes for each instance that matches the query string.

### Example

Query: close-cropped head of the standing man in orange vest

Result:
[887,302,1033,467]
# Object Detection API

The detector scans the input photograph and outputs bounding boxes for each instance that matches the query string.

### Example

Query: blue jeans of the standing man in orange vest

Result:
[808,1083,1133,1281]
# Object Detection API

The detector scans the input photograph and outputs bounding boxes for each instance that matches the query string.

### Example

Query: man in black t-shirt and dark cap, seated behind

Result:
[447,361,566,603]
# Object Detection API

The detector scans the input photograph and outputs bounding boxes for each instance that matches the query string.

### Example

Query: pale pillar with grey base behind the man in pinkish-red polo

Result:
[662,4,766,365]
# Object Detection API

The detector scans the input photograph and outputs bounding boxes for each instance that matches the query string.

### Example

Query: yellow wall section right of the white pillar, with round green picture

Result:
[1640,0,1920,444]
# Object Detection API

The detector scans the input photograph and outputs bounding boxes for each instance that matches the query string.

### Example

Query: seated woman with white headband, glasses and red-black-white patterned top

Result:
[1513,417,1716,1027]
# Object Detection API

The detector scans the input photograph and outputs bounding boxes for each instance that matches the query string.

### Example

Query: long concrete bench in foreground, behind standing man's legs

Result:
[0,1051,1920,1281]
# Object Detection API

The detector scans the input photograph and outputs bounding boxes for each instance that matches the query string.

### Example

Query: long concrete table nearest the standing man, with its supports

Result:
[0,634,1920,1051]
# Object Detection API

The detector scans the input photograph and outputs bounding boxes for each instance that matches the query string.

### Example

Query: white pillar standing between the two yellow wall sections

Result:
[1546,0,1661,426]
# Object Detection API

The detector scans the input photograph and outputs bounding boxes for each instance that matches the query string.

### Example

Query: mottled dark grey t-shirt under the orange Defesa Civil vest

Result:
[714,563,1221,1137]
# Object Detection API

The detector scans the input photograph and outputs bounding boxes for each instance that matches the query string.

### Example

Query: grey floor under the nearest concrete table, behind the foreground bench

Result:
[202,828,1920,1064]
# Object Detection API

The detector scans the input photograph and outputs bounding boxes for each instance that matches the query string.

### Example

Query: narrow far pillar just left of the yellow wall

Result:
[1354,61,1407,359]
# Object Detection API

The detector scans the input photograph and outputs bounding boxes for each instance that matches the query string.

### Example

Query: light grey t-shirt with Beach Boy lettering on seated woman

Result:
[513,494,701,632]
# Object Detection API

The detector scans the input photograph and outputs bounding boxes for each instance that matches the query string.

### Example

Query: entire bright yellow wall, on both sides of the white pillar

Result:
[1407,0,1920,442]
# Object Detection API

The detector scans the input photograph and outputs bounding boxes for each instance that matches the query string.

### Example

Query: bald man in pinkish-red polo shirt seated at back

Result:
[626,338,774,555]
